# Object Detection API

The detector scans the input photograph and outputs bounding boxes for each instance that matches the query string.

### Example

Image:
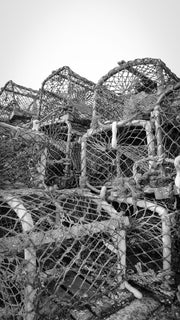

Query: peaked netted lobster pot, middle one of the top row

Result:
[40,66,95,122]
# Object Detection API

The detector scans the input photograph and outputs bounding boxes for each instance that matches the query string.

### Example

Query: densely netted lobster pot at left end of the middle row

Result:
[0,114,81,189]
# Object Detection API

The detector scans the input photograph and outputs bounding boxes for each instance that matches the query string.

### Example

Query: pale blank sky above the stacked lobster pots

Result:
[0,0,180,89]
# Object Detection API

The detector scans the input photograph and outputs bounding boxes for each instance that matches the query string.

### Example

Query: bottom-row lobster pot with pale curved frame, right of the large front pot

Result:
[111,197,174,290]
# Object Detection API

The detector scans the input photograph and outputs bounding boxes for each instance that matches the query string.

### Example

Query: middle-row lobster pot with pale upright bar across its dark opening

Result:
[81,120,155,190]
